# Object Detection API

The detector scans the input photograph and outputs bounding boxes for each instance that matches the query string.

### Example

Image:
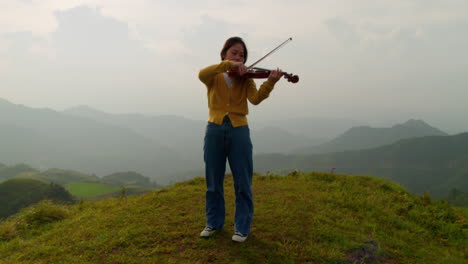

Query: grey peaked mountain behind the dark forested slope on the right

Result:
[295,119,448,154]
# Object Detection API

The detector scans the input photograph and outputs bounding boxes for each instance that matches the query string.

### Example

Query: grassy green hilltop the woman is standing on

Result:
[0,172,468,264]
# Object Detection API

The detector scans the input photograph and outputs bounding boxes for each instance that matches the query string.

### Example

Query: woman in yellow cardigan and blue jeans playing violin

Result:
[199,37,282,242]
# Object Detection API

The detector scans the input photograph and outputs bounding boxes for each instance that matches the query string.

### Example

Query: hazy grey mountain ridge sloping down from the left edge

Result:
[0,100,183,184]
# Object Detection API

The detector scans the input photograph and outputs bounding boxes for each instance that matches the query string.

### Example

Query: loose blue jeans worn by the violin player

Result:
[203,117,254,234]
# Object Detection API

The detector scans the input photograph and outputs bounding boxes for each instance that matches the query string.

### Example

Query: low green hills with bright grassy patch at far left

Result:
[0,164,160,218]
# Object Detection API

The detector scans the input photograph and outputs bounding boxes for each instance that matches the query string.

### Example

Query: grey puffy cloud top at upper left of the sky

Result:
[52,6,145,65]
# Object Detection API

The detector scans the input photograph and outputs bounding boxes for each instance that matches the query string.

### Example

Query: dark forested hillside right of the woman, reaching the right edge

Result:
[255,133,468,198]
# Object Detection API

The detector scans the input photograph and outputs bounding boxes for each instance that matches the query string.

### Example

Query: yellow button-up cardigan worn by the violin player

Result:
[198,61,275,127]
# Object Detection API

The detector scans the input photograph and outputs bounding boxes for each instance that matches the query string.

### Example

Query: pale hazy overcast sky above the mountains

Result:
[0,0,468,132]
